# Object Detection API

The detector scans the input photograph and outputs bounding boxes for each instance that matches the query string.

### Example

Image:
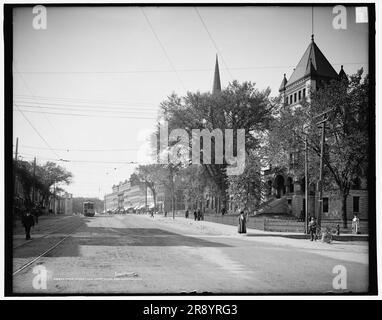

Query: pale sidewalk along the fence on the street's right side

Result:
[142,215,369,241]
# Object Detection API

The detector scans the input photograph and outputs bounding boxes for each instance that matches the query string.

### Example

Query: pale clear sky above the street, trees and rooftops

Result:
[13,6,369,198]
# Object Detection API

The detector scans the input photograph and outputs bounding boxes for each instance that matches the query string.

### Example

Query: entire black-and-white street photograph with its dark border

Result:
[3,3,378,298]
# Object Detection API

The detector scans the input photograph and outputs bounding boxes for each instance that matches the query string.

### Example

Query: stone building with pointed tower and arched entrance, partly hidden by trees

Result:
[260,36,368,220]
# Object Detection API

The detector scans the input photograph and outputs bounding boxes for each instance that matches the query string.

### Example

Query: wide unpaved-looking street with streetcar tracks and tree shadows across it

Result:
[13,214,368,294]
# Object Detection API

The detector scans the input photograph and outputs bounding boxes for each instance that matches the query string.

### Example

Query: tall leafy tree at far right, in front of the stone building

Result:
[310,69,371,228]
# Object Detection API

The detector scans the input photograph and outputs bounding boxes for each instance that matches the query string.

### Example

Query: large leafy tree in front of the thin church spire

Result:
[161,81,275,206]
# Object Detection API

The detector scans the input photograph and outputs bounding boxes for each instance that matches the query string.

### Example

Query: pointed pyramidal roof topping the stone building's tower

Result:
[288,35,338,84]
